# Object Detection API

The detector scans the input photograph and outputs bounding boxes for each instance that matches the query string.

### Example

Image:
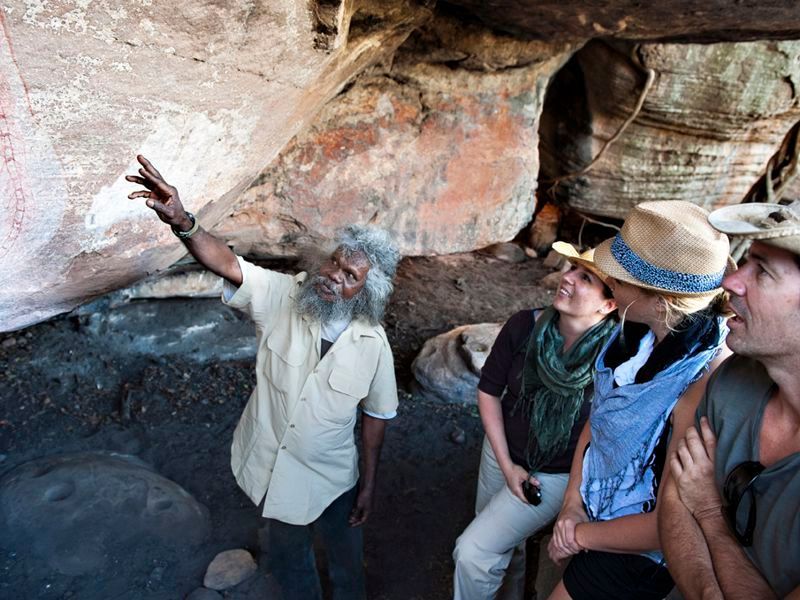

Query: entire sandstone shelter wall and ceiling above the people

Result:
[0,0,800,330]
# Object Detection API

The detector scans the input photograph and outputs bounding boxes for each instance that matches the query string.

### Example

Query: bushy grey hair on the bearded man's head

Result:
[333,225,400,324]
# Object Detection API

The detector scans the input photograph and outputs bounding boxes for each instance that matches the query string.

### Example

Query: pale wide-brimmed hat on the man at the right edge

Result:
[708,201,800,254]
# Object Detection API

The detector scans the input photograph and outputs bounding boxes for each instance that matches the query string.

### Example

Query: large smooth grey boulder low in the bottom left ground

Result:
[0,452,210,576]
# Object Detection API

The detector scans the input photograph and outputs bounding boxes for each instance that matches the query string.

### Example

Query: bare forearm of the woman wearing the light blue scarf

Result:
[575,513,660,554]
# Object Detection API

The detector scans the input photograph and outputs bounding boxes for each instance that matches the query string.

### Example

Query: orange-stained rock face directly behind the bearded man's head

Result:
[215,19,573,255]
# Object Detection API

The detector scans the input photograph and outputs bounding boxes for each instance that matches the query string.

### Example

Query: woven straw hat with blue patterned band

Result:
[594,200,736,296]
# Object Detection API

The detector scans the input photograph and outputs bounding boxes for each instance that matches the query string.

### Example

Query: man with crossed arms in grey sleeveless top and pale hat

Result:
[659,203,800,598]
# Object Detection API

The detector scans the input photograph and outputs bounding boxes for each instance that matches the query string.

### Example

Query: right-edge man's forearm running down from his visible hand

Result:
[699,510,777,600]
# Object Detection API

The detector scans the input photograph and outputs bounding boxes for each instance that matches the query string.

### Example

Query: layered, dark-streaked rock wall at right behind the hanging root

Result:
[541,42,800,218]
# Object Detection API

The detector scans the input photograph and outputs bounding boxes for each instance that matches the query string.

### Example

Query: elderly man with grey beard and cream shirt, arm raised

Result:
[126,156,399,600]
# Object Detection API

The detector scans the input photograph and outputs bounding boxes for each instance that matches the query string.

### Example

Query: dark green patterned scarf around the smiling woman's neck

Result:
[514,306,617,473]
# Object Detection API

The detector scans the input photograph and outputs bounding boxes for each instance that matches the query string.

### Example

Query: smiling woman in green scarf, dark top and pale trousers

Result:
[453,242,616,600]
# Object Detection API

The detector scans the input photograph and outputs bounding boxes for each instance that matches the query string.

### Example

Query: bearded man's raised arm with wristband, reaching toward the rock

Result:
[125,155,242,287]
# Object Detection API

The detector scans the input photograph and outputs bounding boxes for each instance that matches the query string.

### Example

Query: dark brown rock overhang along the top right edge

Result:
[448,0,800,43]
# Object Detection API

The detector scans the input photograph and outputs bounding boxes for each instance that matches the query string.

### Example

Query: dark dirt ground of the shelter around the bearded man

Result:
[0,253,549,600]
